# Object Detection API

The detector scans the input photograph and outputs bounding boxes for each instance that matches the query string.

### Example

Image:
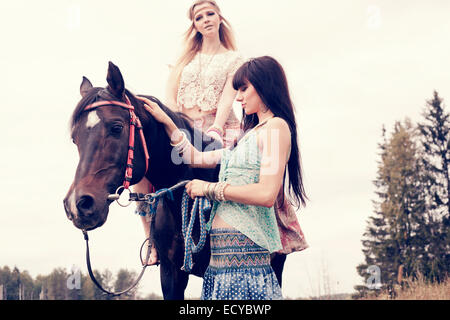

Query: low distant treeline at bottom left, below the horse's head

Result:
[0,266,161,300]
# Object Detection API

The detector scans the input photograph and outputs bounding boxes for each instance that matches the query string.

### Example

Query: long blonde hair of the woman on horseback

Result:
[173,0,236,90]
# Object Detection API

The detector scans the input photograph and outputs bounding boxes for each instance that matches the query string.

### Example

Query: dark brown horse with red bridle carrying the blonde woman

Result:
[64,62,286,300]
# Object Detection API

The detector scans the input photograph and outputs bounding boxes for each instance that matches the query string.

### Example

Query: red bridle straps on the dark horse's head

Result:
[84,96,150,189]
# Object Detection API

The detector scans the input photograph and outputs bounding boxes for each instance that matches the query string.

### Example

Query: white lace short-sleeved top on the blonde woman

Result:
[177,51,244,111]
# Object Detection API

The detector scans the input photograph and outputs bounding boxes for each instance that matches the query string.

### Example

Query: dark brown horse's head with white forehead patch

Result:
[64,62,146,230]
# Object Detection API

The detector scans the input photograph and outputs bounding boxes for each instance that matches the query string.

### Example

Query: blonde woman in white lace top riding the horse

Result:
[134,0,244,265]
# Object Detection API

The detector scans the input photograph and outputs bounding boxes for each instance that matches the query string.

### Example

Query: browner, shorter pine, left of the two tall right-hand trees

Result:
[356,120,425,295]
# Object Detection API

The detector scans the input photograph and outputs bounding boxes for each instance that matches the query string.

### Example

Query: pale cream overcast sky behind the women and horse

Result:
[0,0,450,298]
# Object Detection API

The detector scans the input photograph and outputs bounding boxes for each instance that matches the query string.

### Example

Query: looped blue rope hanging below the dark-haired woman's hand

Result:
[181,190,211,272]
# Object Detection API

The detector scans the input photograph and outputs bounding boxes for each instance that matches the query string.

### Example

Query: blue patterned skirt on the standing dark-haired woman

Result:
[201,229,283,300]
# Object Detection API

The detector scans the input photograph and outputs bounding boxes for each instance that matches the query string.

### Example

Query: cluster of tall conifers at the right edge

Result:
[355,91,450,298]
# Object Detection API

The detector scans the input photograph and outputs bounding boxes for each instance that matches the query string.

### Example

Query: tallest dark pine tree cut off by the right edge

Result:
[418,91,450,281]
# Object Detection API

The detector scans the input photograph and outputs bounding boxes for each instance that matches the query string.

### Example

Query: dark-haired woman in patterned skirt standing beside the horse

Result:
[138,56,307,300]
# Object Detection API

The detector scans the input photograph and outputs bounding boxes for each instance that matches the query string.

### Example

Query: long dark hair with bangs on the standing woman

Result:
[233,56,308,207]
